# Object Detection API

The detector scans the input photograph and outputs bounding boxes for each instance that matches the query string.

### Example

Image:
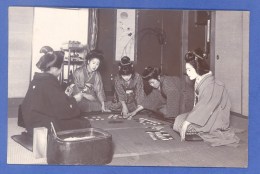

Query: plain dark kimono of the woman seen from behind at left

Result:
[21,73,90,133]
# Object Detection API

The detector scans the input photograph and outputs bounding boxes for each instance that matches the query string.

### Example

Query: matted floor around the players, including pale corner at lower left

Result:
[7,98,248,168]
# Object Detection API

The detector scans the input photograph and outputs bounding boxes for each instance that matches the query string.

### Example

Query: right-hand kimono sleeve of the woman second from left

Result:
[94,72,106,102]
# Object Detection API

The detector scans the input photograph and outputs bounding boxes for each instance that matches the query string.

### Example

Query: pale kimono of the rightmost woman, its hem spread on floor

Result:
[173,73,239,146]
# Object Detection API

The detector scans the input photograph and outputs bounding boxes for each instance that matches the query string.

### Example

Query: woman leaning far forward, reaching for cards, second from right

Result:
[128,67,193,119]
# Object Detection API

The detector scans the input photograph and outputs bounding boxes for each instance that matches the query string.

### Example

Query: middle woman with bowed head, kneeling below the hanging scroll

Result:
[110,56,144,116]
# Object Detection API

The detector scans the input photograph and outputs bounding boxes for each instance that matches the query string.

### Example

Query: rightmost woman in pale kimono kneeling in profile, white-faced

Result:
[173,49,239,145]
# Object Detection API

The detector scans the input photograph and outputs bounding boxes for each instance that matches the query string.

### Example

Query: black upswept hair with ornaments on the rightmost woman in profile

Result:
[185,48,210,75]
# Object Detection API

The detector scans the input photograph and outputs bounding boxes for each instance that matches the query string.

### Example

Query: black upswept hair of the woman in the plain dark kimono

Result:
[36,46,64,72]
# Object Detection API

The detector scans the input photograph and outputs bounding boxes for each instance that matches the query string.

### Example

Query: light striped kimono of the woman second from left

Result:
[73,64,105,112]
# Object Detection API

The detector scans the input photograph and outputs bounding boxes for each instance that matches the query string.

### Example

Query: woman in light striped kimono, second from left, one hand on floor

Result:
[73,50,109,112]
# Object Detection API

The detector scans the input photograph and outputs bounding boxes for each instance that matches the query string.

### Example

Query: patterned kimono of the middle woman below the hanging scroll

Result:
[110,73,144,112]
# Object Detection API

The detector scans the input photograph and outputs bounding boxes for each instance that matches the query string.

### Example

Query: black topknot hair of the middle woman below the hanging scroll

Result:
[118,56,135,76]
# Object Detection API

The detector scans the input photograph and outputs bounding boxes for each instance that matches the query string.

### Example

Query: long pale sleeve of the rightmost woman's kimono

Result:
[187,83,223,126]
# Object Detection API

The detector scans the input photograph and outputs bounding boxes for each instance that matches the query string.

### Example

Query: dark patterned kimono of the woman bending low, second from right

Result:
[141,76,193,118]
